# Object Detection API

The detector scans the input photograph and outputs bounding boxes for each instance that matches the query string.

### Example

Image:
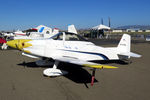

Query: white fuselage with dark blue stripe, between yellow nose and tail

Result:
[24,39,119,61]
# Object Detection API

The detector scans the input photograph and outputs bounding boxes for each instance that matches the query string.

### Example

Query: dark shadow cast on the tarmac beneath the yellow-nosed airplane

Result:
[18,60,129,88]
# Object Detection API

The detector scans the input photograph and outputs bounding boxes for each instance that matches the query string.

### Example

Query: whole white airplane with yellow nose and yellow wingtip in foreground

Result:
[7,32,141,85]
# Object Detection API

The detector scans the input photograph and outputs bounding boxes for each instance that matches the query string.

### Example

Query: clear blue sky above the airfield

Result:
[0,0,150,30]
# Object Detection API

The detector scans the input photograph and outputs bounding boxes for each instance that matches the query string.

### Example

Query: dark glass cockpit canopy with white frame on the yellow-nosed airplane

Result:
[51,32,87,41]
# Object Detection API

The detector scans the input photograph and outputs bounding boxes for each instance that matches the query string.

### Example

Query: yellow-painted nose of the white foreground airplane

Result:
[6,39,32,50]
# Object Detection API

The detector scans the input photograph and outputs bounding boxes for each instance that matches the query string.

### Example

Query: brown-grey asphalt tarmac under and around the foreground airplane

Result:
[0,40,150,100]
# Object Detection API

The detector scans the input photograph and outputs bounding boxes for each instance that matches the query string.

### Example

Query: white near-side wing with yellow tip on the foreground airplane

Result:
[53,57,118,69]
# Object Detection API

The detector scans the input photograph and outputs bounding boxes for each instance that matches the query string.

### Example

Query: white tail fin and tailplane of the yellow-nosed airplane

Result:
[117,34,141,58]
